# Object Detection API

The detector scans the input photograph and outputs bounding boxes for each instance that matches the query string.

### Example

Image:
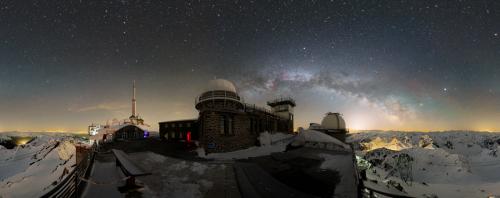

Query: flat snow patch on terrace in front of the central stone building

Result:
[129,152,237,198]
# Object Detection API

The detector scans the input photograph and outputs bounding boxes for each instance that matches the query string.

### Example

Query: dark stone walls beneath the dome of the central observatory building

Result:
[196,100,293,153]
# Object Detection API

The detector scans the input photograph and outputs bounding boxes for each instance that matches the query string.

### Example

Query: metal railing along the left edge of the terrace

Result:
[41,144,97,198]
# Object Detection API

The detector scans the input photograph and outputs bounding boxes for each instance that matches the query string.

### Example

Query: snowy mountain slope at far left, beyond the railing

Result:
[0,133,84,197]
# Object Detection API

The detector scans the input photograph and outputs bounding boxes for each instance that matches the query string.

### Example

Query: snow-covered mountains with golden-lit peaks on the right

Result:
[347,131,500,197]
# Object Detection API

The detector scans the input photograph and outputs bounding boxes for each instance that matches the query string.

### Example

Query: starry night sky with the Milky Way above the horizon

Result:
[0,0,500,132]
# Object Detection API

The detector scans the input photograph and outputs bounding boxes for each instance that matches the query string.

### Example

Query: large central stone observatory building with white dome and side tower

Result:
[159,79,295,153]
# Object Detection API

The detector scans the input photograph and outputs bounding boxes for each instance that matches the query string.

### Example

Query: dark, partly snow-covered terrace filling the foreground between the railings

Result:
[79,132,356,197]
